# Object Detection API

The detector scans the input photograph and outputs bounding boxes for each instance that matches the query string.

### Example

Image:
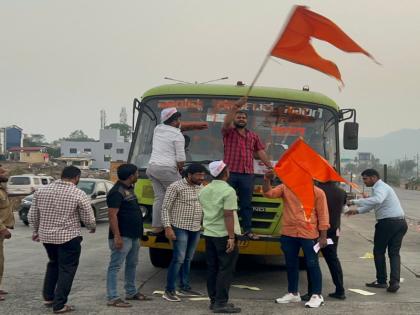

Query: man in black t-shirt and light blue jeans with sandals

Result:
[106,164,149,307]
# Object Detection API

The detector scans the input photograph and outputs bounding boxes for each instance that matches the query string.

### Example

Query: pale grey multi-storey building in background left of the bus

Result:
[60,129,130,169]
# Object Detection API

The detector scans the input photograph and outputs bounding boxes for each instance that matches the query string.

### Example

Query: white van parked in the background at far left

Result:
[7,174,54,196]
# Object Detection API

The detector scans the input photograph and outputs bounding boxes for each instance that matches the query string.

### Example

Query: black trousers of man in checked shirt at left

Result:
[42,236,82,311]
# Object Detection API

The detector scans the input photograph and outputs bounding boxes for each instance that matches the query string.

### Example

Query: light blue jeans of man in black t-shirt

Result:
[106,236,140,301]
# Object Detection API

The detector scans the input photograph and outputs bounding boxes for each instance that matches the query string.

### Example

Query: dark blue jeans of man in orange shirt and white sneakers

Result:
[280,235,322,294]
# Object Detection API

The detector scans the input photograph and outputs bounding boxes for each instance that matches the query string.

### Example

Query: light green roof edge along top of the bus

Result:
[142,84,338,110]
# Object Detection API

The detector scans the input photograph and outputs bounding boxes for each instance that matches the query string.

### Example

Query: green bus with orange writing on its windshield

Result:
[128,84,358,267]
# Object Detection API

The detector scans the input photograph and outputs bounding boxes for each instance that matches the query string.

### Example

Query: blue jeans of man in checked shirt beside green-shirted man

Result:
[166,227,200,291]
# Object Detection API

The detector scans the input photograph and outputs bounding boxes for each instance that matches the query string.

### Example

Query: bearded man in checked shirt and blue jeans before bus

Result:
[162,164,206,302]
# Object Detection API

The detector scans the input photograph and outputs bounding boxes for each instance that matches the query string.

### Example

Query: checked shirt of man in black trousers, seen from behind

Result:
[28,180,96,244]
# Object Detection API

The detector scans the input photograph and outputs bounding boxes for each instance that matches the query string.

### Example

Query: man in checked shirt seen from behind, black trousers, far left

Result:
[28,166,96,313]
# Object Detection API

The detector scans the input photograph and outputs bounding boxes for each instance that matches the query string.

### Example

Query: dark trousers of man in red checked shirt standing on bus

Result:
[228,172,254,233]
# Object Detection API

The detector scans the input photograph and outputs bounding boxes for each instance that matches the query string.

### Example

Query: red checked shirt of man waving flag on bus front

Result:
[222,127,264,174]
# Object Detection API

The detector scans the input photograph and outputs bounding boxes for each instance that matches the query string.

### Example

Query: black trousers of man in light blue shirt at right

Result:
[373,218,408,284]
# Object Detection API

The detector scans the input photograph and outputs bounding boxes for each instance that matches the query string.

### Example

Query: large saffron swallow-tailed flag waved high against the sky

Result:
[270,6,374,83]
